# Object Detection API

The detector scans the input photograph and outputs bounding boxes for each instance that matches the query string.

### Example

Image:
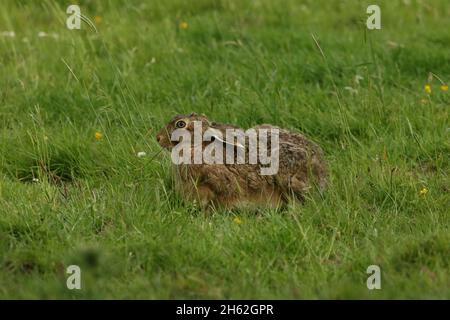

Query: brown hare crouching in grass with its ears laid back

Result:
[156,113,327,209]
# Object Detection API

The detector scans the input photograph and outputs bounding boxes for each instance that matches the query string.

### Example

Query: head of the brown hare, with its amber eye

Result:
[156,113,211,149]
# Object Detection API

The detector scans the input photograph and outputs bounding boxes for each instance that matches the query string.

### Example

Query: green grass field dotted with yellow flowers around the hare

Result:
[0,0,450,299]
